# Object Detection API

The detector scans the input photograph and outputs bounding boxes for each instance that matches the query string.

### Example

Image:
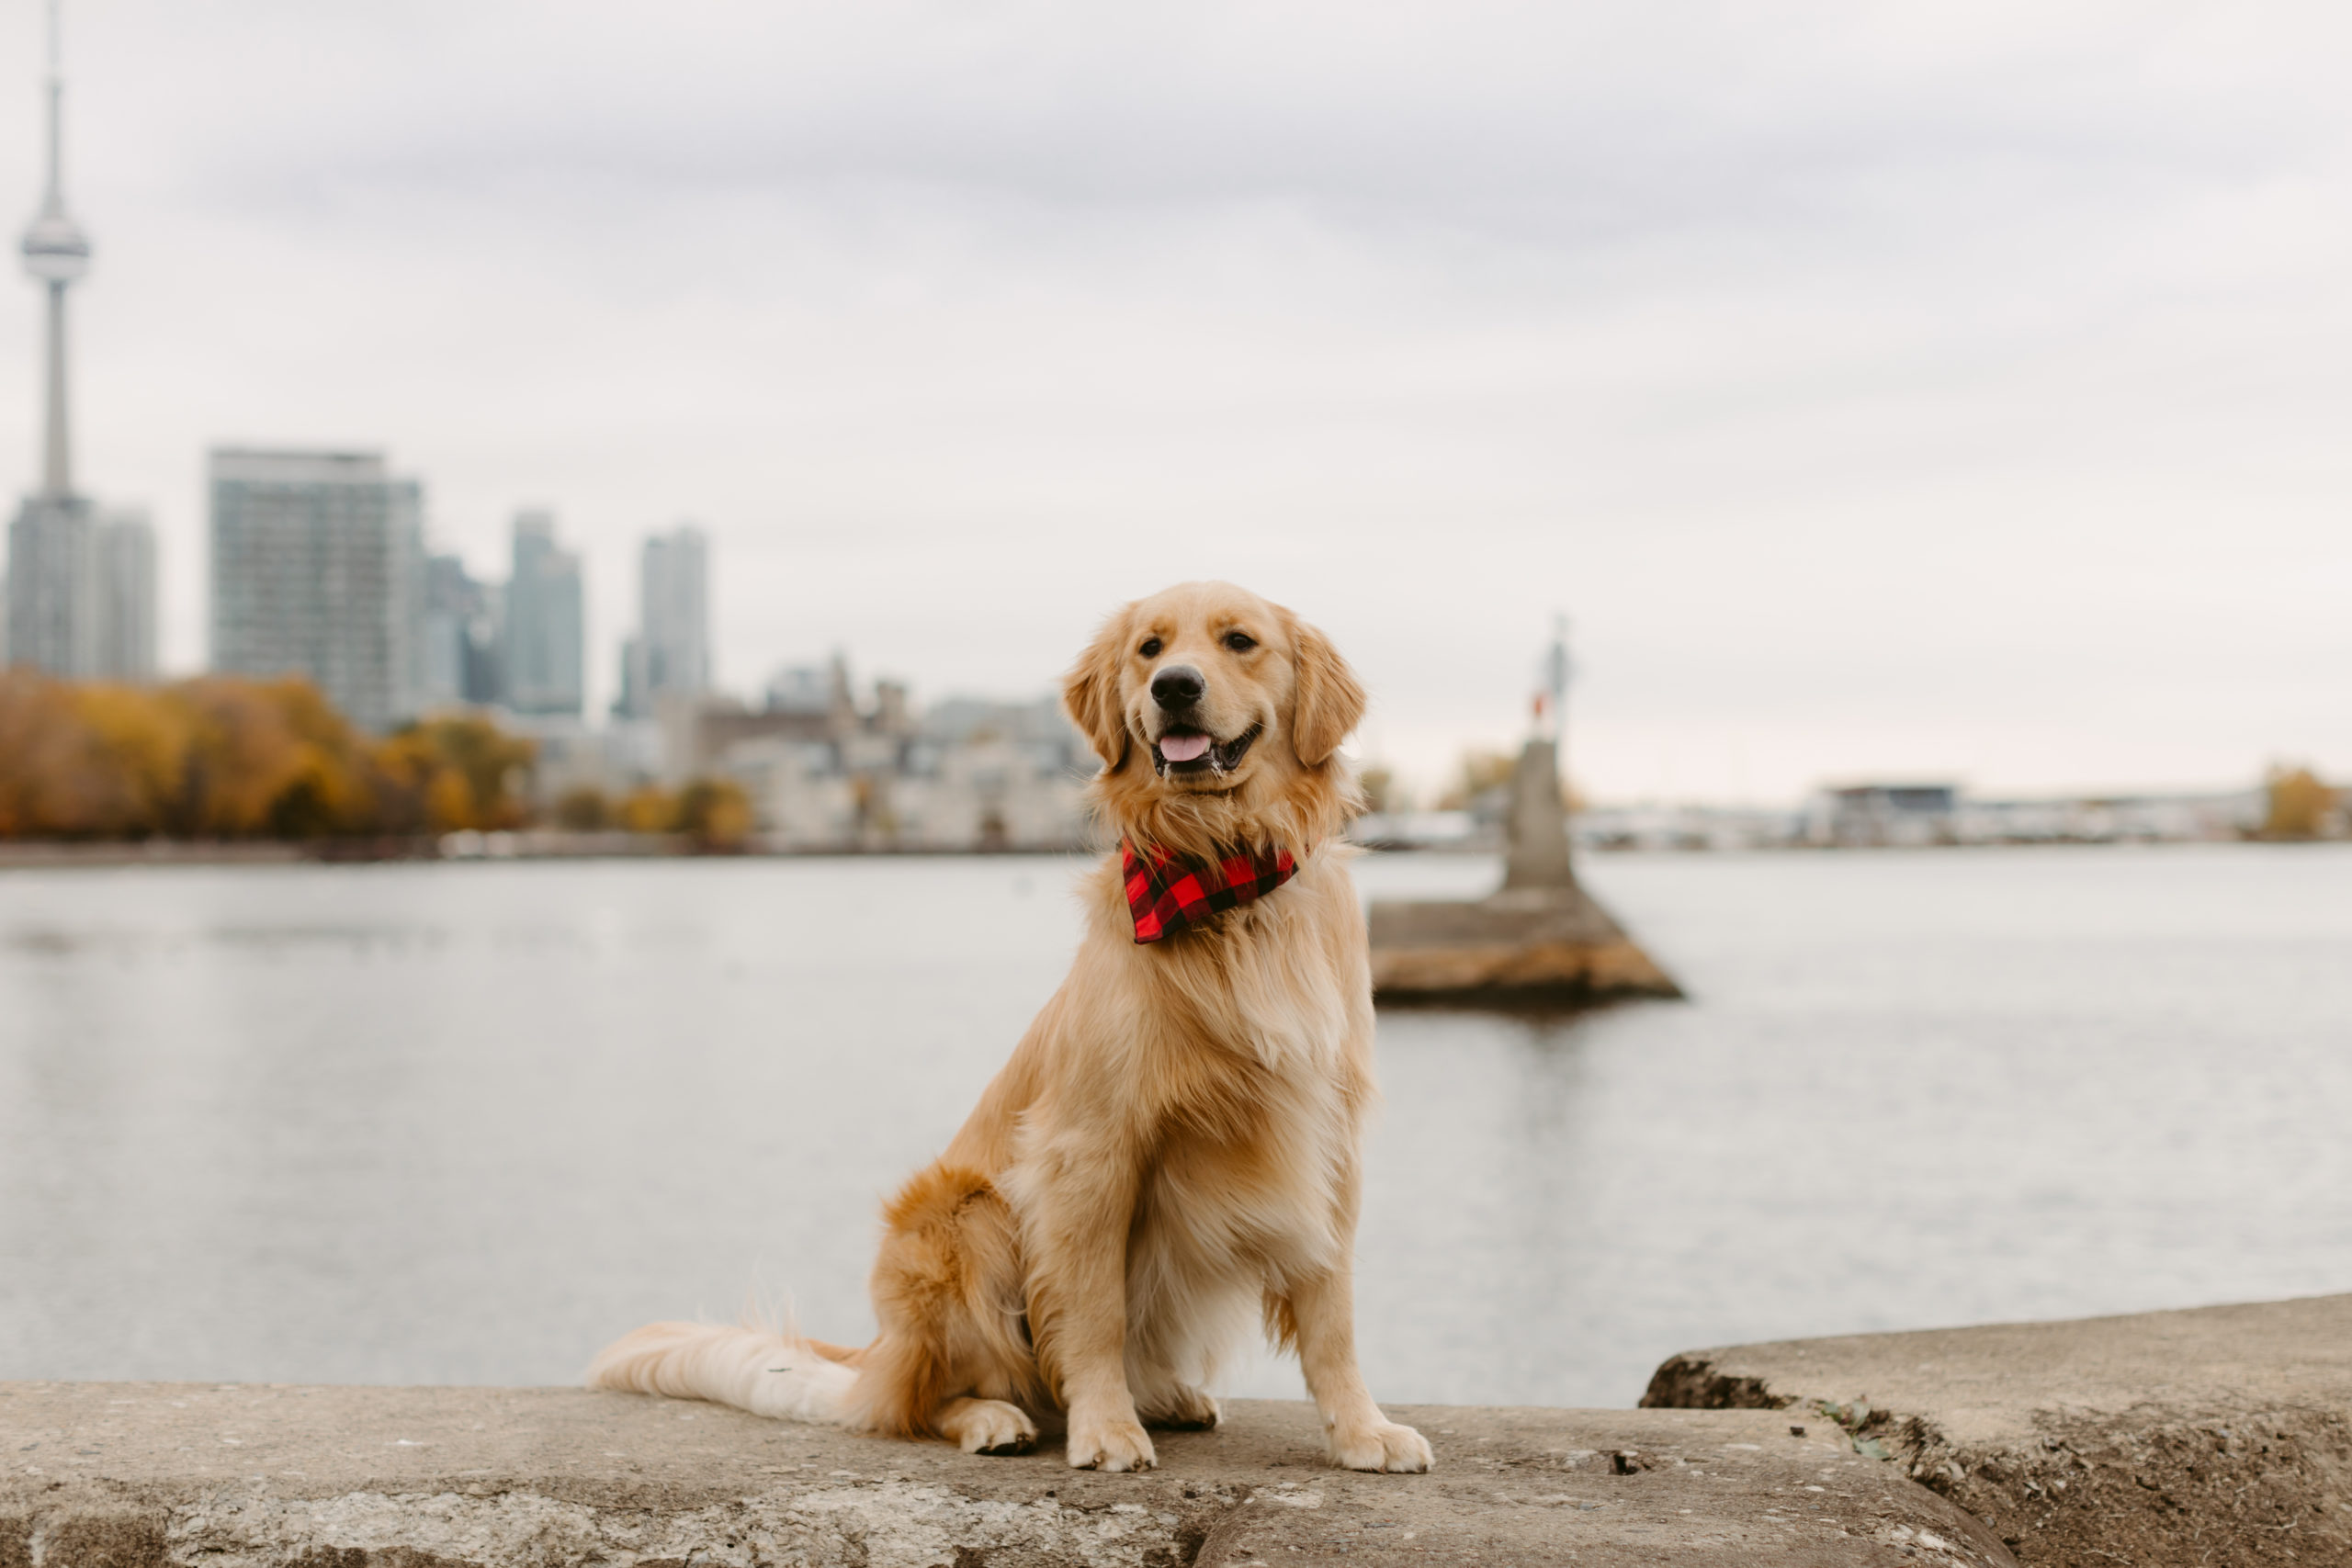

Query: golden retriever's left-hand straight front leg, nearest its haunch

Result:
[1028,1161,1159,1470]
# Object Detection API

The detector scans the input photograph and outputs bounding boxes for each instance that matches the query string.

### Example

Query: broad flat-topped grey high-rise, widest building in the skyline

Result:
[211,449,424,731]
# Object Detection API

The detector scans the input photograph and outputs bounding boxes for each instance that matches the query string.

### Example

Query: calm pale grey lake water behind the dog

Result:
[0,846,2352,1405]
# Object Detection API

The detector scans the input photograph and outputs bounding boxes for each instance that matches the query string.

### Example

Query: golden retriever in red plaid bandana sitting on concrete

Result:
[588,583,1430,1472]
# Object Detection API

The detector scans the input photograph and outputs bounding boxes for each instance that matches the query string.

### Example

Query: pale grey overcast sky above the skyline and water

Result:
[0,0,2352,799]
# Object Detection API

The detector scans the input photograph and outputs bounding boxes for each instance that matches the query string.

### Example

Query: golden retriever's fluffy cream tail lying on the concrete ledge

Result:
[588,1324,858,1425]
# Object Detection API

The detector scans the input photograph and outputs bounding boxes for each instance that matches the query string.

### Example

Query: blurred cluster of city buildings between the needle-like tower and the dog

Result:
[192,449,1091,849]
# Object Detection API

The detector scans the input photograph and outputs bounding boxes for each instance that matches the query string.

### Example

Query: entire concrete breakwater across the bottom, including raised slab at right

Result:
[0,1298,2352,1568]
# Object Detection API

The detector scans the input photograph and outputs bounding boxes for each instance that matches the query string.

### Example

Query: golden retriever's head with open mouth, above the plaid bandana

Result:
[1063,583,1364,851]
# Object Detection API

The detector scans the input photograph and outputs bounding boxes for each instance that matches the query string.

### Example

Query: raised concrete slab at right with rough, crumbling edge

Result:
[1642,1295,2352,1568]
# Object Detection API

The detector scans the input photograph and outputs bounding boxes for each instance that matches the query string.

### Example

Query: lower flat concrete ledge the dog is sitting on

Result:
[0,1382,2013,1568]
